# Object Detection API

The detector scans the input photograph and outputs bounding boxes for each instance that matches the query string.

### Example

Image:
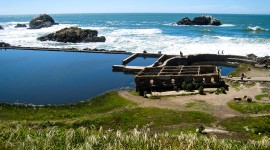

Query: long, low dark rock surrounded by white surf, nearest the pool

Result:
[37,27,106,43]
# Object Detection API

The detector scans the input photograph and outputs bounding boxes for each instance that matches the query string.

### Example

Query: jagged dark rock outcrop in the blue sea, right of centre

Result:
[177,16,221,26]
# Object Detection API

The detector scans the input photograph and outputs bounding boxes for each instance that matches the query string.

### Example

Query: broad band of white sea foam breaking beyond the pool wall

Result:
[0,22,270,56]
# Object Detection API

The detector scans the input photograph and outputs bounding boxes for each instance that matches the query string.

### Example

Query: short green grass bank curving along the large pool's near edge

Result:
[0,92,137,121]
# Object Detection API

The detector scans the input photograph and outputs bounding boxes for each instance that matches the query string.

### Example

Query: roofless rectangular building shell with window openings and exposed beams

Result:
[135,65,222,95]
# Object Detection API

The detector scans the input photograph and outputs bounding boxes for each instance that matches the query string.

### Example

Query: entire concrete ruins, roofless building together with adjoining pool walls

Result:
[113,53,256,95]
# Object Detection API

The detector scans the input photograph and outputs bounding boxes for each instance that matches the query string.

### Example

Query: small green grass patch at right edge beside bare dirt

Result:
[228,101,270,114]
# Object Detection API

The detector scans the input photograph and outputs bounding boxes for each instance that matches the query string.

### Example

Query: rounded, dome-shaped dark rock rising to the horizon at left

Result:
[29,14,58,29]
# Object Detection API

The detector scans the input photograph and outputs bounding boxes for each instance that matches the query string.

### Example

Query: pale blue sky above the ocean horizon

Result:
[0,0,270,15]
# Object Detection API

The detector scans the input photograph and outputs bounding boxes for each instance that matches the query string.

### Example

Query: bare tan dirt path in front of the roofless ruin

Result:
[119,84,266,118]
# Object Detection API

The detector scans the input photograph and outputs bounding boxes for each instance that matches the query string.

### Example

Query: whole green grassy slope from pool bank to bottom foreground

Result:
[0,91,270,149]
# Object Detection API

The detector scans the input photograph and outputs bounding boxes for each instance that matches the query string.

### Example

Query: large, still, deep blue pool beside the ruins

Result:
[0,50,135,105]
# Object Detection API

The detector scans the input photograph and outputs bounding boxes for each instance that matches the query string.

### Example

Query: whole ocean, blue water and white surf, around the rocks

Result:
[0,14,270,56]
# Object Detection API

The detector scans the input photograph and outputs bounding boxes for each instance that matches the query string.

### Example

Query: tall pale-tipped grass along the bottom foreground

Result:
[0,125,270,150]
